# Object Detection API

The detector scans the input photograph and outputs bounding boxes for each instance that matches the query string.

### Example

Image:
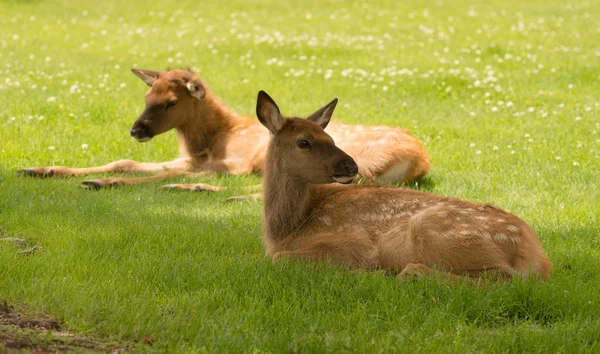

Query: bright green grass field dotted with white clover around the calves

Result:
[0,0,600,353]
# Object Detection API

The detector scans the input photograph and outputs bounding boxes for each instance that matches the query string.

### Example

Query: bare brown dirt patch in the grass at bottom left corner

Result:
[0,301,135,354]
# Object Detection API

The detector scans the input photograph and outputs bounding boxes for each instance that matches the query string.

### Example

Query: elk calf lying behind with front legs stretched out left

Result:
[21,69,430,190]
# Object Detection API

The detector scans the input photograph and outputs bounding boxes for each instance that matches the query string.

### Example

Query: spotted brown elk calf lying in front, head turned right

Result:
[256,91,552,279]
